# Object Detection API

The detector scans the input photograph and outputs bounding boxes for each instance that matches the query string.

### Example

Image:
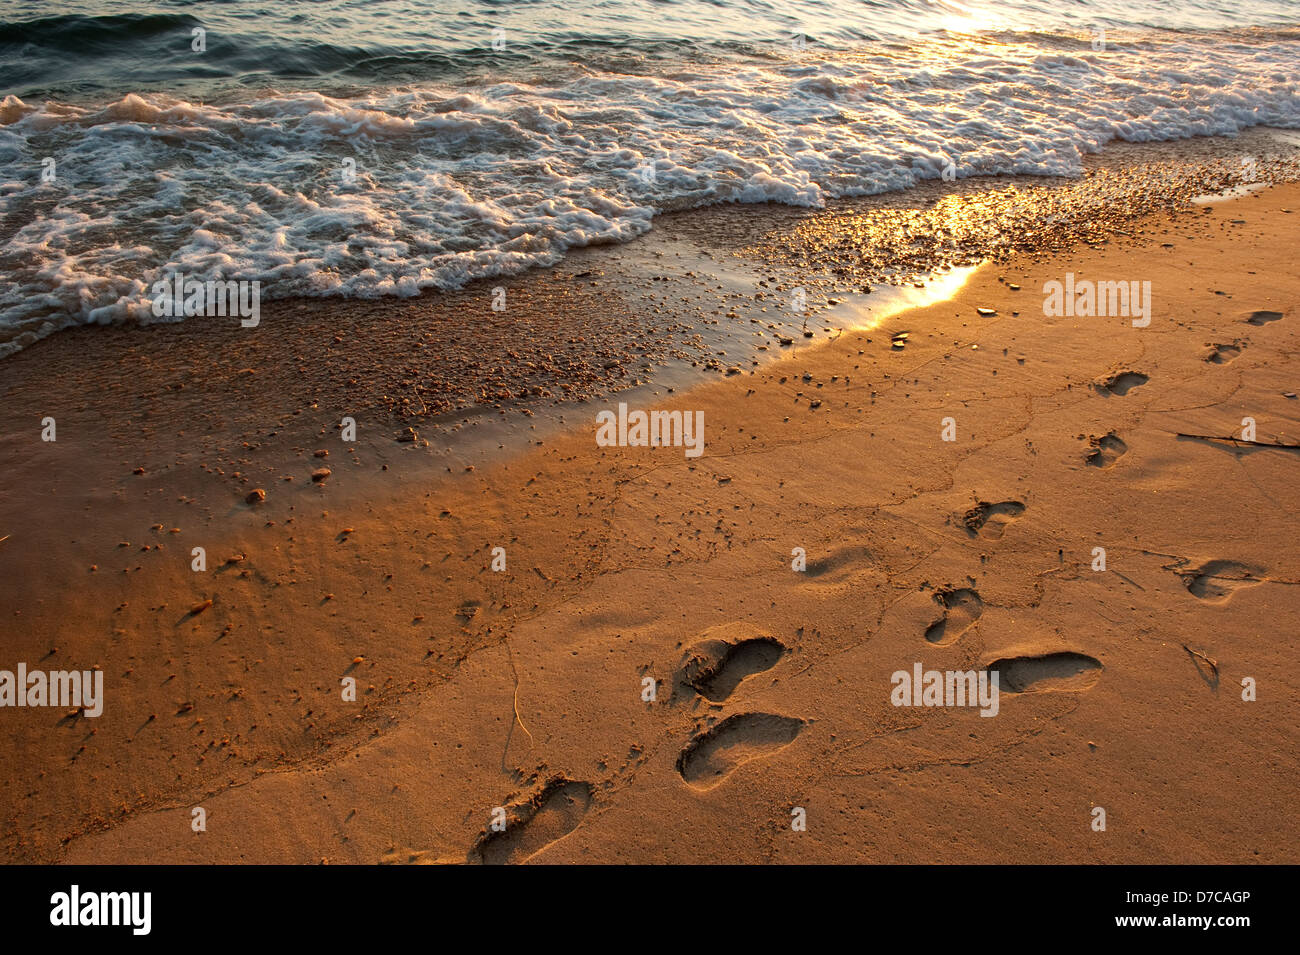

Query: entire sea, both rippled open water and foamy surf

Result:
[0,0,1300,357]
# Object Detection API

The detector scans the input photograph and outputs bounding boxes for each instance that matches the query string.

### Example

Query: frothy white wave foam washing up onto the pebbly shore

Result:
[0,32,1300,356]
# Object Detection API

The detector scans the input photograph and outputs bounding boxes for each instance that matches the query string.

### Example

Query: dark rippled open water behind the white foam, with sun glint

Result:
[0,0,1297,99]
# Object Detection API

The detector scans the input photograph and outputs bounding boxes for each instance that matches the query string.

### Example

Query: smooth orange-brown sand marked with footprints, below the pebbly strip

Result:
[0,178,1300,863]
